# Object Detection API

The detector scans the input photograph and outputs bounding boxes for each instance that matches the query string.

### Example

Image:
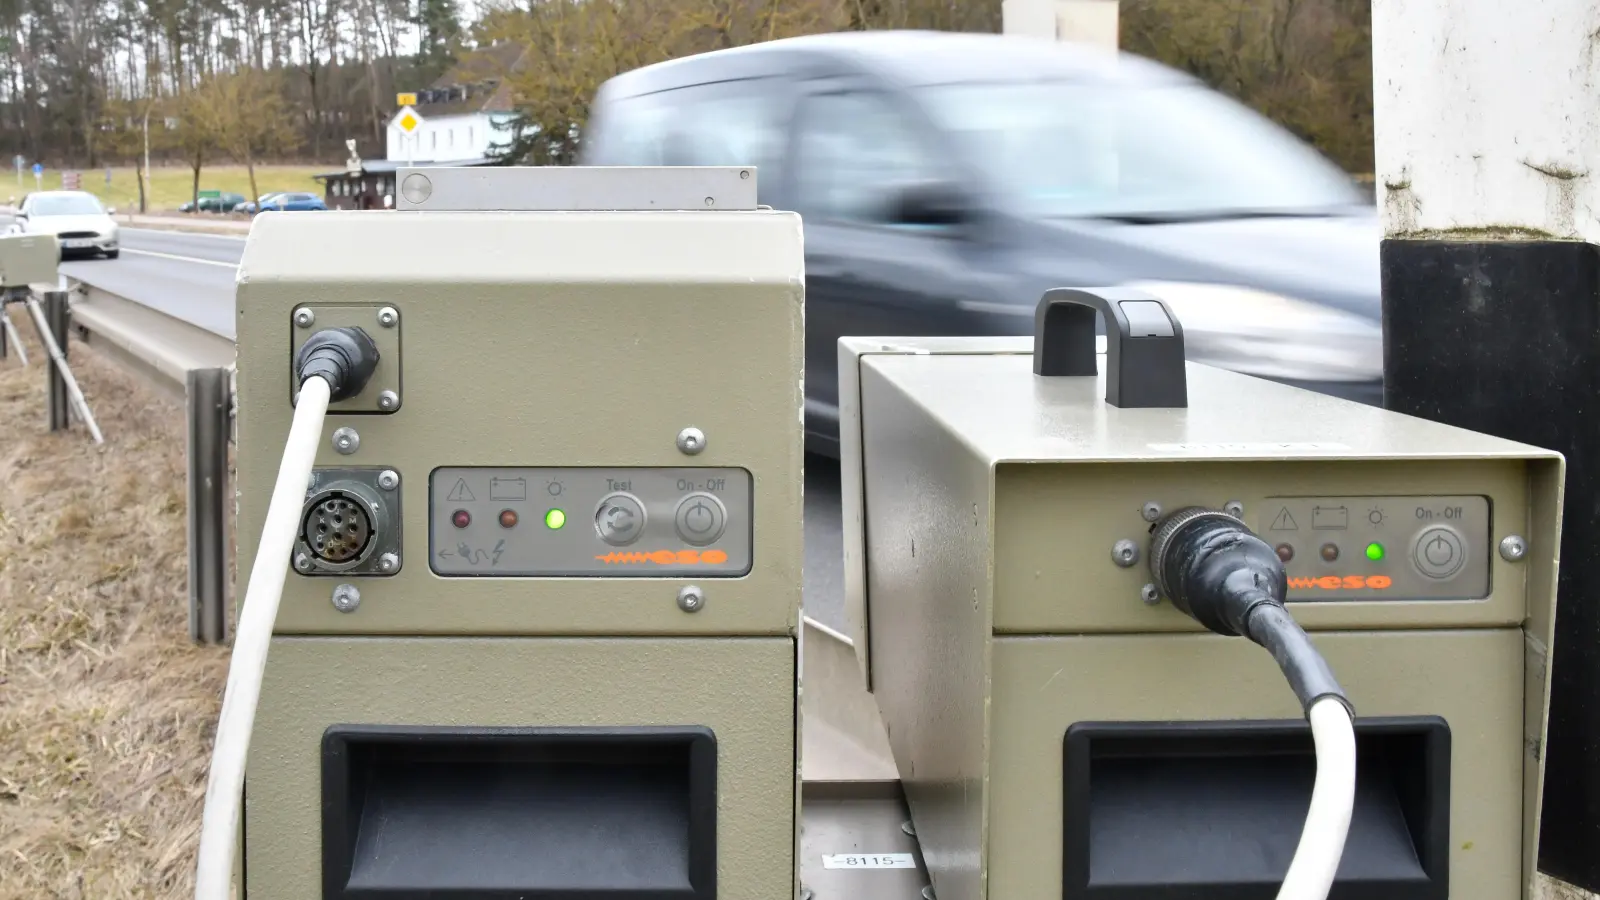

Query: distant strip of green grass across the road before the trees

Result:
[0,165,324,213]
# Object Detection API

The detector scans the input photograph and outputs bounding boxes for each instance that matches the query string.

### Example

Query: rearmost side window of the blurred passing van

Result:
[584,78,789,203]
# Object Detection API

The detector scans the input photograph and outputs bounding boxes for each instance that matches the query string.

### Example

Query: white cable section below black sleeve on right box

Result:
[1278,697,1355,900]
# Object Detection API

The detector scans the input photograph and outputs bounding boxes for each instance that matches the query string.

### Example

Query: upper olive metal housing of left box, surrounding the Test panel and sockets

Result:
[238,211,803,634]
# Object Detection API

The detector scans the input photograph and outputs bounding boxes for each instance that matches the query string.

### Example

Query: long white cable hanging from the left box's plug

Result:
[195,371,330,900]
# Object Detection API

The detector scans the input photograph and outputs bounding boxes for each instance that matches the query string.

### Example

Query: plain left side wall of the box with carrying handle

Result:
[861,360,992,900]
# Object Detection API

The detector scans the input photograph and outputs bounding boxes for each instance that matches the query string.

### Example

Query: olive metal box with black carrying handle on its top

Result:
[840,338,1563,900]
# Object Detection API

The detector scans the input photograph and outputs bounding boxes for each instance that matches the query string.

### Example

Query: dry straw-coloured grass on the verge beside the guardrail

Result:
[0,315,227,900]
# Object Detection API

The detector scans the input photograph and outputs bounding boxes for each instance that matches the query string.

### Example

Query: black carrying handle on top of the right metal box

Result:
[1034,288,1189,410]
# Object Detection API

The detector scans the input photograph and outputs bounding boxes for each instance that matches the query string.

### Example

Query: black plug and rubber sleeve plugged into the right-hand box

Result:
[1150,508,1354,716]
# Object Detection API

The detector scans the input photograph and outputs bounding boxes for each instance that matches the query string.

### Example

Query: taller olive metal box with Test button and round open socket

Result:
[237,168,803,900]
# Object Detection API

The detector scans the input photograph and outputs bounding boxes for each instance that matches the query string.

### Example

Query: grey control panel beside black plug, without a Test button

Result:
[1251,496,1491,601]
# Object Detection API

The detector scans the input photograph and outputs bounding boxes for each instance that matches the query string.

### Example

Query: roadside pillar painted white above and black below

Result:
[1373,0,1600,890]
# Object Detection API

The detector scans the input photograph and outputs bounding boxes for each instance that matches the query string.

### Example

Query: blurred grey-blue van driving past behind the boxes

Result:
[581,32,1382,453]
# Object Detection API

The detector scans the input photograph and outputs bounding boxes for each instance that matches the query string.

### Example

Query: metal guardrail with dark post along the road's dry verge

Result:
[67,279,234,644]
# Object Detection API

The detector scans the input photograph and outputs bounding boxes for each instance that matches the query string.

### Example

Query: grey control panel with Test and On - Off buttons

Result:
[429,466,752,578]
